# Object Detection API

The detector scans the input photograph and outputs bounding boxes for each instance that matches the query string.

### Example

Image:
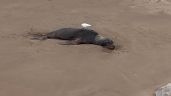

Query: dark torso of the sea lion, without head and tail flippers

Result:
[47,28,98,44]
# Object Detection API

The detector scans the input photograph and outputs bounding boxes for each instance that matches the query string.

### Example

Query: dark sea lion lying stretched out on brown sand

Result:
[33,28,115,50]
